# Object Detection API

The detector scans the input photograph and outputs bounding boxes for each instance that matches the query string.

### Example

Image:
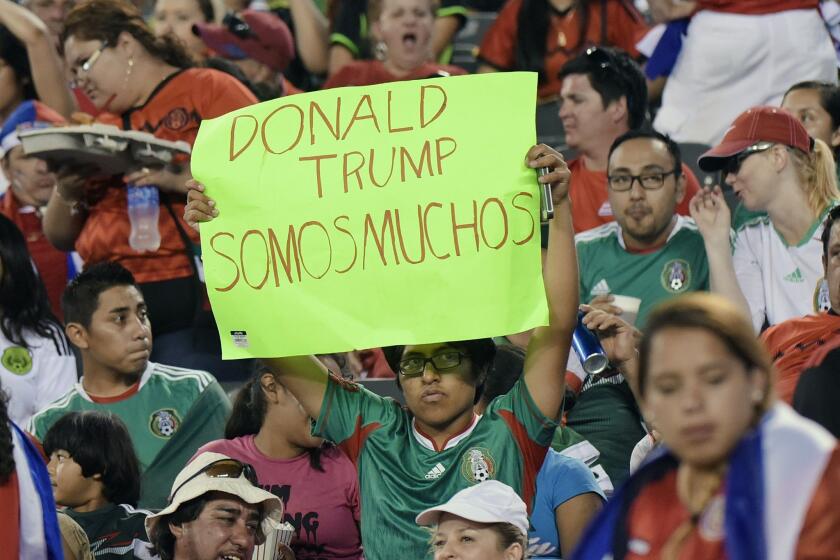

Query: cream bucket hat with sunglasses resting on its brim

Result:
[146,452,283,535]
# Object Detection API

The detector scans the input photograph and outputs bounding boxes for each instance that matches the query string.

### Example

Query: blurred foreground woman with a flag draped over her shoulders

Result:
[572,293,840,560]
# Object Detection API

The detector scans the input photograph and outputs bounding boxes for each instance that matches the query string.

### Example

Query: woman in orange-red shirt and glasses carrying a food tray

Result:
[44,0,256,367]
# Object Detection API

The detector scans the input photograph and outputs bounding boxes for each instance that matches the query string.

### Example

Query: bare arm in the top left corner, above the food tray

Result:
[0,0,76,119]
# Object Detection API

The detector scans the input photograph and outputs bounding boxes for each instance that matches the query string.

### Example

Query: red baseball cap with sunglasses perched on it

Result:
[193,10,295,72]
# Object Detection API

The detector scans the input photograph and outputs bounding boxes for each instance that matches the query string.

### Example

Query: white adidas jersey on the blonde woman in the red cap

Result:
[733,211,828,332]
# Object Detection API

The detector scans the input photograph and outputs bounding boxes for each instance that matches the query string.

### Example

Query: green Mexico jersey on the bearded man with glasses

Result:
[575,216,709,328]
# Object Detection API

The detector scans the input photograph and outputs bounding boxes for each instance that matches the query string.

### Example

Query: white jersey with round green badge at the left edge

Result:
[0,327,76,426]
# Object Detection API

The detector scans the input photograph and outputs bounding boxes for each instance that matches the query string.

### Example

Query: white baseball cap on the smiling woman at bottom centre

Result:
[415,480,528,536]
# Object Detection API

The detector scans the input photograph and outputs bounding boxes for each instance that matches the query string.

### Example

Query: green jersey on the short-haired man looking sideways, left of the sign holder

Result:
[28,362,230,508]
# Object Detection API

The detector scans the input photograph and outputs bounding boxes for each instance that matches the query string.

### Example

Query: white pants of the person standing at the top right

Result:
[653,0,837,145]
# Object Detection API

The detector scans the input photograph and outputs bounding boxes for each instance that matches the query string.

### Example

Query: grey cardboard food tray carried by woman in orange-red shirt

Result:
[19,124,190,175]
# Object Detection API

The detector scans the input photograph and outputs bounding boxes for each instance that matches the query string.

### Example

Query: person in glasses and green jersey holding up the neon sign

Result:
[185,145,578,560]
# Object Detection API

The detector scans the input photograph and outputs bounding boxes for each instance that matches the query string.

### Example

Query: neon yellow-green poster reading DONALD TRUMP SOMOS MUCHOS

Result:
[192,73,548,358]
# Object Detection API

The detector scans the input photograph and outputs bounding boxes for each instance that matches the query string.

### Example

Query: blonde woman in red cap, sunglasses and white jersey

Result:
[690,107,840,331]
